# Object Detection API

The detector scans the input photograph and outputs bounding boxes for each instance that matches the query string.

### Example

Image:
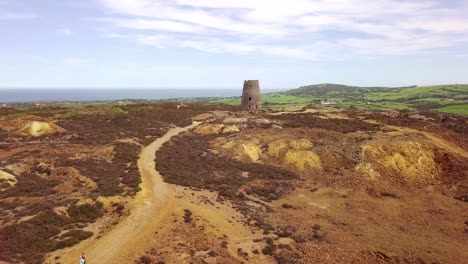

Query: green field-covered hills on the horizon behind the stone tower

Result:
[215,83,468,115]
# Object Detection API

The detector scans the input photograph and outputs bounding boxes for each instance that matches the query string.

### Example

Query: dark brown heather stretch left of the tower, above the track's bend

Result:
[57,102,236,145]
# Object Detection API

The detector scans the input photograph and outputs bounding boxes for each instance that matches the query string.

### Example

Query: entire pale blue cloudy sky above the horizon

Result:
[0,0,468,89]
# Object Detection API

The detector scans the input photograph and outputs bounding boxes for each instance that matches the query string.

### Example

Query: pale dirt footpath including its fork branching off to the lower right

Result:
[46,122,273,263]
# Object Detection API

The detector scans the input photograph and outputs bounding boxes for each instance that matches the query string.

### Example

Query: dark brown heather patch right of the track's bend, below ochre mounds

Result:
[157,134,298,199]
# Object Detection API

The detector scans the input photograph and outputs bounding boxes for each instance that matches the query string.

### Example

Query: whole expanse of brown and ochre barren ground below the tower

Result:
[0,104,468,263]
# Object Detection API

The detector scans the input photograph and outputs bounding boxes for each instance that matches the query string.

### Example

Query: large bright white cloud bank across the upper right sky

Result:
[99,0,468,59]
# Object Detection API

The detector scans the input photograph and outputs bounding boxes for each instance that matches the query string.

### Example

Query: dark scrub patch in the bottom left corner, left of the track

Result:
[0,207,100,263]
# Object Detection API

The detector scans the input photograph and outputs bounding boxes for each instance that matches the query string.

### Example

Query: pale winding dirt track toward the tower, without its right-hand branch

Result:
[55,122,199,263]
